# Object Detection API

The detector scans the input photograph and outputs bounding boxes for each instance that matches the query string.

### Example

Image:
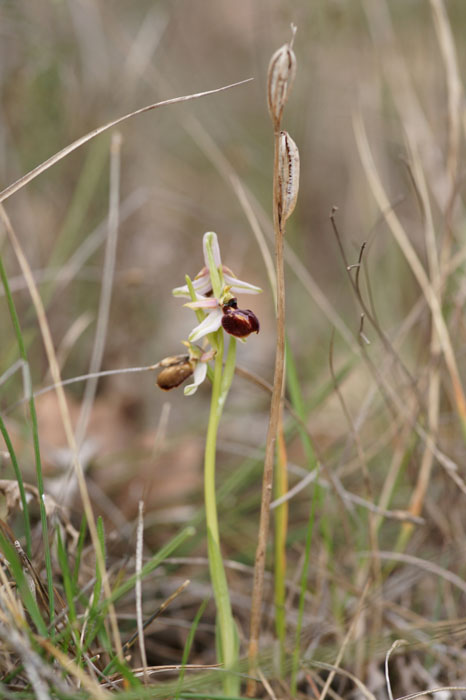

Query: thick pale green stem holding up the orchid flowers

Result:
[204,329,239,695]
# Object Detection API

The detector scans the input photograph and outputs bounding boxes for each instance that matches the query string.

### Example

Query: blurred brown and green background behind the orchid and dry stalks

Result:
[0,0,466,688]
